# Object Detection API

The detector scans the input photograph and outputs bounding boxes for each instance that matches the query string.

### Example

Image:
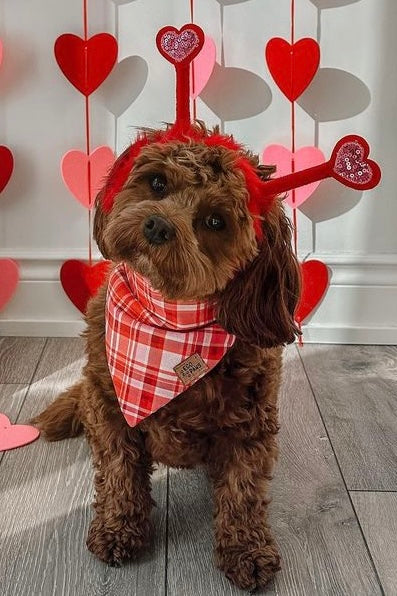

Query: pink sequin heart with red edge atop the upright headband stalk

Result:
[156,23,204,66]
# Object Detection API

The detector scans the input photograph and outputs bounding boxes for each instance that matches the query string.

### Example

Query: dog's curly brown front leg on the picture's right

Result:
[210,440,280,589]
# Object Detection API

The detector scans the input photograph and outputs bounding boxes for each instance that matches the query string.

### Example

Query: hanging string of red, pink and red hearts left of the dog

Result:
[54,0,118,313]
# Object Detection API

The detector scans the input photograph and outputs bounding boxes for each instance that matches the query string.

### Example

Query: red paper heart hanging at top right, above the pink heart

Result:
[265,37,320,101]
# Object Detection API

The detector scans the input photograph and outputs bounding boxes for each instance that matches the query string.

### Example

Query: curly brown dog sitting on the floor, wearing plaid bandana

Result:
[34,124,300,589]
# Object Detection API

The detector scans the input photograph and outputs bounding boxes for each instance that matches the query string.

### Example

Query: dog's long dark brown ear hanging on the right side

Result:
[217,201,300,347]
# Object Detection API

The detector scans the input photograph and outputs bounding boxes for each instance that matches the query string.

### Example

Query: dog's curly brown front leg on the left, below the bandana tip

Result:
[87,394,153,566]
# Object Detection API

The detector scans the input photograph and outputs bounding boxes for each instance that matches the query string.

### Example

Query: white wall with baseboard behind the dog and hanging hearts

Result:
[0,0,397,343]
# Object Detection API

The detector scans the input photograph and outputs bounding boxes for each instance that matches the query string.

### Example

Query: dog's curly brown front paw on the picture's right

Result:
[216,542,280,590]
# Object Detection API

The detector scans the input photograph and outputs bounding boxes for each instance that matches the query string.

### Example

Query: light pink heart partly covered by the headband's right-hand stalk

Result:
[262,145,325,208]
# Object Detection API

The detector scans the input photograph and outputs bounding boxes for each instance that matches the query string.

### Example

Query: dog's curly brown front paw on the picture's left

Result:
[87,517,150,567]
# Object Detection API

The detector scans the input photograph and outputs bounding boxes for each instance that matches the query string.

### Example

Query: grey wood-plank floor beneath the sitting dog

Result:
[0,338,397,596]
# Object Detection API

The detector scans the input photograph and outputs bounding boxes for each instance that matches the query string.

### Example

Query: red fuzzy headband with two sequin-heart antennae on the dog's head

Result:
[102,23,381,230]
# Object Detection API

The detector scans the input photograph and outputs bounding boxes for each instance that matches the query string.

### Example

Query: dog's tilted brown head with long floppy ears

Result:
[94,125,299,346]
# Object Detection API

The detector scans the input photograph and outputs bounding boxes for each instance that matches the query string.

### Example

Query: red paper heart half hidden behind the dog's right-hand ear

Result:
[295,259,328,323]
